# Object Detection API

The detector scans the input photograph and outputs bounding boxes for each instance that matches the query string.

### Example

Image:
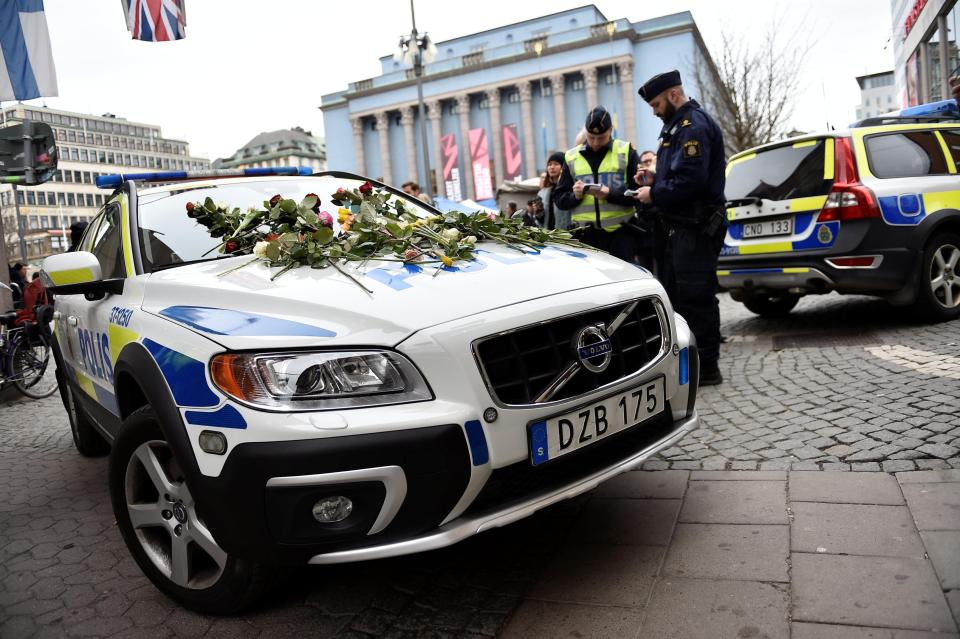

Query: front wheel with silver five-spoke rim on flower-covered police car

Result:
[109,406,277,615]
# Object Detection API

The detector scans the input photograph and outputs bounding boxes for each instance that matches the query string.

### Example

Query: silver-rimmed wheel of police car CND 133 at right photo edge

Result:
[917,233,960,322]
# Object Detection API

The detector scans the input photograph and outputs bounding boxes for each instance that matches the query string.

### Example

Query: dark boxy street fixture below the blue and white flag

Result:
[0,121,58,186]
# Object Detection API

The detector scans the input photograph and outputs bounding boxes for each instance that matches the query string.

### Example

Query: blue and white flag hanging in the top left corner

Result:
[0,0,57,101]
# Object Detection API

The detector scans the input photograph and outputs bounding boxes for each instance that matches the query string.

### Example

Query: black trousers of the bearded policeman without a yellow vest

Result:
[660,227,726,363]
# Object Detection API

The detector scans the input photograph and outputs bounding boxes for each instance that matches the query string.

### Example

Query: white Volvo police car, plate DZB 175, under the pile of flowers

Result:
[44,169,698,613]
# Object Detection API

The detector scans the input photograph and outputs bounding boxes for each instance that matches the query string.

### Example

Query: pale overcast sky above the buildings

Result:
[20,0,893,160]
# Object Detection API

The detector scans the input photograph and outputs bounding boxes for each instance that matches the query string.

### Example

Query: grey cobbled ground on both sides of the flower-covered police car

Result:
[0,296,960,639]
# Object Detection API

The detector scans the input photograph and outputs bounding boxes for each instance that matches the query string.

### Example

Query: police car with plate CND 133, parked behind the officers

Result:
[718,100,960,320]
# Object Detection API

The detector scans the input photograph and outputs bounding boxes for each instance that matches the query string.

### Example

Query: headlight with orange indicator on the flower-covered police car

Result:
[210,351,432,411]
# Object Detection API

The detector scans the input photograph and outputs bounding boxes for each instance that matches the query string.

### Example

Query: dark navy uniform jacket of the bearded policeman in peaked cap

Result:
[652,100,726,220]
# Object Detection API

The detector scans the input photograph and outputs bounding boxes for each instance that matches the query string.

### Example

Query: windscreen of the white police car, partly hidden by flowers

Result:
[137,176,435,272]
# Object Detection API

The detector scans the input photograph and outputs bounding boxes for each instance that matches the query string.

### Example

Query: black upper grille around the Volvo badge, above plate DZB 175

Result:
[474,298,664,406]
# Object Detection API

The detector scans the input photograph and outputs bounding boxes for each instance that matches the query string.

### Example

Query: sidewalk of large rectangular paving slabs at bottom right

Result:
[503,470,960,639]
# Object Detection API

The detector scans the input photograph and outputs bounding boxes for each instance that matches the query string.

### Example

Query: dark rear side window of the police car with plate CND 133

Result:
[864,131,948,178]
